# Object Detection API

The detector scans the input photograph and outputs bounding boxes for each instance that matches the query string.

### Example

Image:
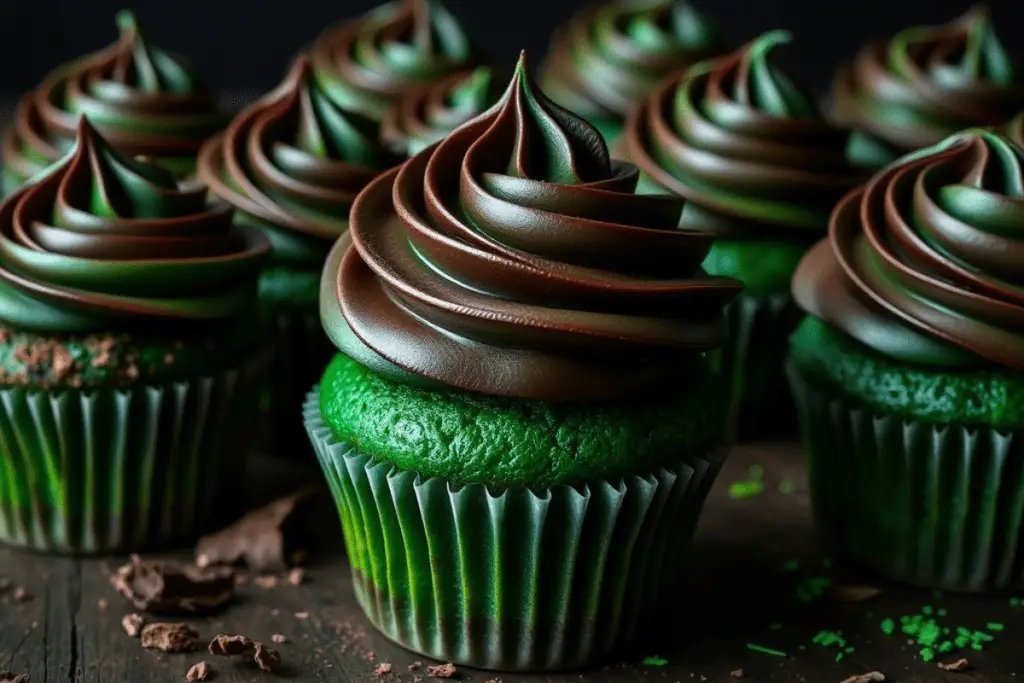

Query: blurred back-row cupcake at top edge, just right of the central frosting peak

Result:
[541,0,725,146]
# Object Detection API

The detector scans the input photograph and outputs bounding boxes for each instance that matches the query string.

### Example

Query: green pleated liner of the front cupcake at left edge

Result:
[0,355,265,554]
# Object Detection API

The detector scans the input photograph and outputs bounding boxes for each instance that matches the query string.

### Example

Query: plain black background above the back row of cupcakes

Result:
[0,0,1024,97]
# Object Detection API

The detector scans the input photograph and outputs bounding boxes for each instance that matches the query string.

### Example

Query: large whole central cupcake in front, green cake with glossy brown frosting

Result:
[305,52,740,671]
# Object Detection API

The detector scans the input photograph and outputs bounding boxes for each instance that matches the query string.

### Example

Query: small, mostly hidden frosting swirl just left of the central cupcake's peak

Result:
[381,67,501,157]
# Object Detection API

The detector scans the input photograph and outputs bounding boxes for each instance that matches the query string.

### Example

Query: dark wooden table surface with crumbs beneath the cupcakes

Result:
[0,444,1024,683]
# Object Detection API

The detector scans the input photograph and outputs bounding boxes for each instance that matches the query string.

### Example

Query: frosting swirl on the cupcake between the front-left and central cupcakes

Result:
[199,55,398,269]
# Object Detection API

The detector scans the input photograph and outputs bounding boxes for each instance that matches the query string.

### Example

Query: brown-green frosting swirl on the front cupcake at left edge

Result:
[0,117,269,333]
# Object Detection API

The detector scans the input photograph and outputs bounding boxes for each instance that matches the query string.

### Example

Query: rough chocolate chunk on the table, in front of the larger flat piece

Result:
[111,555,234,614]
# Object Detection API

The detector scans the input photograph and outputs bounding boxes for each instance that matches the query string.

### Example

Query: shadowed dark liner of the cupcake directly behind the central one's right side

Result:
[715,293,802,439]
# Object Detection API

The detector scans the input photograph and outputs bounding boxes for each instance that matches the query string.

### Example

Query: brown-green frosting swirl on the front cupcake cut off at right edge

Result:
[793,130,1024,370]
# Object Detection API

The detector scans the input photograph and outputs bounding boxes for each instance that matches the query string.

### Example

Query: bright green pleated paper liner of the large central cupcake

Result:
[305,391,724,671]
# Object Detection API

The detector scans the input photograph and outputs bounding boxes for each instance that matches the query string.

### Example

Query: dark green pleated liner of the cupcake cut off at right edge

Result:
[787,364,1024,593]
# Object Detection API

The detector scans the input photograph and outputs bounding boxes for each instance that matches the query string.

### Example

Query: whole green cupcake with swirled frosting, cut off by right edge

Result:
[790,130,1024,592]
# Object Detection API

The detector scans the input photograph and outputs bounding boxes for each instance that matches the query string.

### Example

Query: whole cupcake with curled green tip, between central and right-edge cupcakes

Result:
[621,31,863,436]
